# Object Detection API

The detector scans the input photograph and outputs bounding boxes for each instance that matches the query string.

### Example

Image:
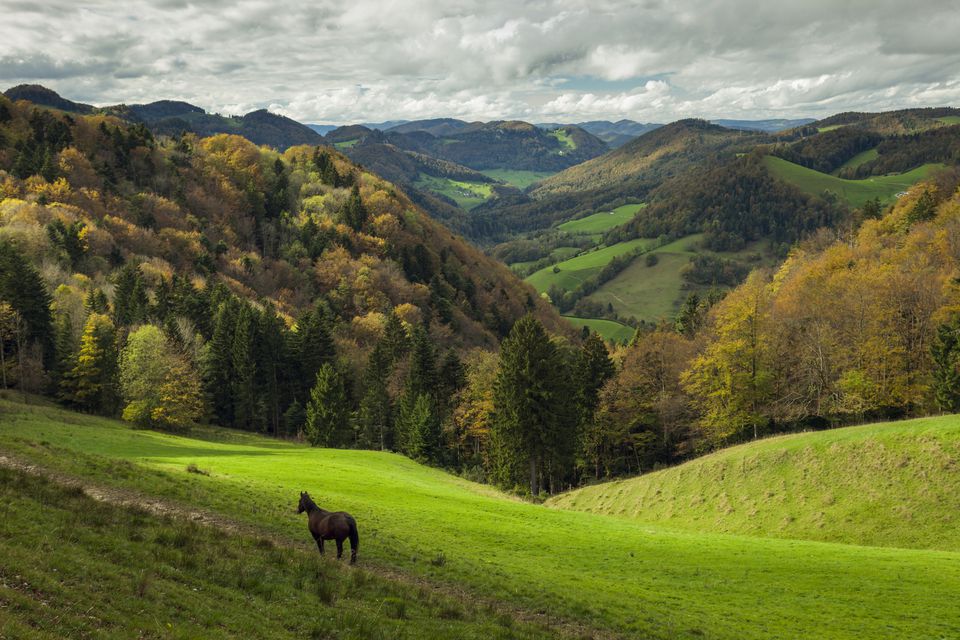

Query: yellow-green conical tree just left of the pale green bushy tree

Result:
[63,313,119,415]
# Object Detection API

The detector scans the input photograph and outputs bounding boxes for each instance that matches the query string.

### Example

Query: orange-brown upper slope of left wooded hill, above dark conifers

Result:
[0,89,561,345]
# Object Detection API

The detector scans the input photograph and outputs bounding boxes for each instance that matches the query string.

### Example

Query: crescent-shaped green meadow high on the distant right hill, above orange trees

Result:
[763,156,944,207]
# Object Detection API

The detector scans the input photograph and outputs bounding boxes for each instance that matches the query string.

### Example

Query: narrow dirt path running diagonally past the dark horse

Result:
[0,452,622,640]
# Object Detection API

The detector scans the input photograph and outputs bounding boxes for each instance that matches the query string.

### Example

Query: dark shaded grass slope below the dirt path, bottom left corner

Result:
[0,468,554,640]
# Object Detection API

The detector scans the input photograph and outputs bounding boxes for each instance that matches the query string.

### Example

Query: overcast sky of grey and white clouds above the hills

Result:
[0,0,960,123]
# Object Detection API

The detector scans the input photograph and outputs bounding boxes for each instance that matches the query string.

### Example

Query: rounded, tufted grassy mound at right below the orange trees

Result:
[550,416,960,551]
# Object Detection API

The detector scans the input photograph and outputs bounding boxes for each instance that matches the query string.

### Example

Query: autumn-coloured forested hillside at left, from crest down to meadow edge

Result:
[0,92,568,478]
